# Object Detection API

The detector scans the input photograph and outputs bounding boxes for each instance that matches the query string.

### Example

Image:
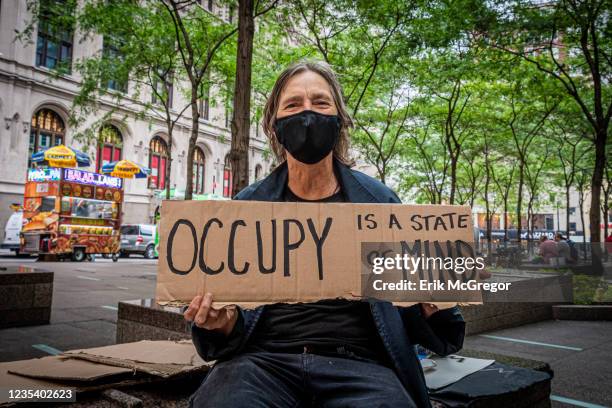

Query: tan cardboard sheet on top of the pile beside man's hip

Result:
[64,340,212,378]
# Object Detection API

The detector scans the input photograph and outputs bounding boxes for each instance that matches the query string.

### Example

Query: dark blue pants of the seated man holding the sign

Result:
[190,353,415,408]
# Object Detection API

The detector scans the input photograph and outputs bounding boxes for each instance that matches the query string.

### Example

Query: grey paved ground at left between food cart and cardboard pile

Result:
[0,255,157,361]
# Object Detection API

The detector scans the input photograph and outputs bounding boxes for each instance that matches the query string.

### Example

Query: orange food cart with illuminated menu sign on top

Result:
[21,167,123,261]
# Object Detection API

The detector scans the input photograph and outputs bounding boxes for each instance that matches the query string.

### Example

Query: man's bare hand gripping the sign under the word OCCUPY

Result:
[183,293,238,336]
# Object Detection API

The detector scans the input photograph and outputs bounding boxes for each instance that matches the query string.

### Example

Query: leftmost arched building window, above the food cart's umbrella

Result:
[28,108,66,167]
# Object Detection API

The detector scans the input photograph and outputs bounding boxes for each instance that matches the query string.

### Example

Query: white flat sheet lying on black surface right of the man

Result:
[425,355,495,390]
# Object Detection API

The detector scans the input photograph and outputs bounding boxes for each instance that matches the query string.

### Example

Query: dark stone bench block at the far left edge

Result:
[0,266,53,328]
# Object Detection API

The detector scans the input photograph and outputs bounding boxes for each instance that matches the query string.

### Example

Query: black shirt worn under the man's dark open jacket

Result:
[246,181,387,364]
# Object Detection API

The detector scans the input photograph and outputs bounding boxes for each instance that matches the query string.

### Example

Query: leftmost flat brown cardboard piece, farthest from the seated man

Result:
[8,356,132,381]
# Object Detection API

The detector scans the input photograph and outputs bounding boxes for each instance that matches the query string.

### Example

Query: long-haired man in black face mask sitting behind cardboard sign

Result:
[185,62,465,408]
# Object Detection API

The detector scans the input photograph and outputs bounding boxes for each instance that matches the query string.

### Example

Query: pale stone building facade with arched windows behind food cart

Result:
[0,0,272,227]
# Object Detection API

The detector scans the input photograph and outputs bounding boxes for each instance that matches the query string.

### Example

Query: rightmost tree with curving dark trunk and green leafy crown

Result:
[479,0,612,242]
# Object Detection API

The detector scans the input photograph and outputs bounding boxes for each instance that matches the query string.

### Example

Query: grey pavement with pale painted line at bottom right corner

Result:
[464,320,612,408]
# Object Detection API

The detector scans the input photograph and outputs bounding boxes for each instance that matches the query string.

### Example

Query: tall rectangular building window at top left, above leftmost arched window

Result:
[36,0,74,72]
